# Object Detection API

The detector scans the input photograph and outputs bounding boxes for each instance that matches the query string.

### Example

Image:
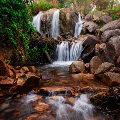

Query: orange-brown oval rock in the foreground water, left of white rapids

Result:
[34,102,49,112]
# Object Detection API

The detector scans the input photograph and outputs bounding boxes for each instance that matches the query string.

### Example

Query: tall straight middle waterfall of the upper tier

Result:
[51,10,60,38]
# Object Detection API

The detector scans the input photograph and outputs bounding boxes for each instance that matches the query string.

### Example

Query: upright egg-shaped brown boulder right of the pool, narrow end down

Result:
[90,56,102,74]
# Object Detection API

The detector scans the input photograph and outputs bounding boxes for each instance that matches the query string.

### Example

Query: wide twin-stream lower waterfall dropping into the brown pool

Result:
[56,41,83,61]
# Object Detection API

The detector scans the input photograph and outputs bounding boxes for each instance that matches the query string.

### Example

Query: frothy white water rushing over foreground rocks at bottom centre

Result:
[47,94,94,120]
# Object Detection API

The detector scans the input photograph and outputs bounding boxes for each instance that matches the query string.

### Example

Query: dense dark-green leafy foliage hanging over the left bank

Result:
[0,0,33,58]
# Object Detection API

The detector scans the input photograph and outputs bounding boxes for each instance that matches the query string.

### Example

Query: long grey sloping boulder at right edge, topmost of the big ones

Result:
[100,19,120,33]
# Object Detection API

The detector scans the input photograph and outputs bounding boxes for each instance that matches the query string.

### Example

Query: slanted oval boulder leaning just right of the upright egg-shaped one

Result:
[95,62,114,75]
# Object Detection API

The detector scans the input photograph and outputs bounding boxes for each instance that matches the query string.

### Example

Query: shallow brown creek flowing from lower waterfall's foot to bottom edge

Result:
[0,62,112,120]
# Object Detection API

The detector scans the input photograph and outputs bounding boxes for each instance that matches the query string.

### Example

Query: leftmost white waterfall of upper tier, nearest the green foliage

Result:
[32,11,43,33]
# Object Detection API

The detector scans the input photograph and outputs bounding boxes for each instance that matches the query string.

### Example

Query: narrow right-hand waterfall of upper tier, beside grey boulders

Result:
[74,14,82,37]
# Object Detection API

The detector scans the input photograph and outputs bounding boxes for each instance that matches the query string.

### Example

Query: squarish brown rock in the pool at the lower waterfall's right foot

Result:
[69,60,85,73]
